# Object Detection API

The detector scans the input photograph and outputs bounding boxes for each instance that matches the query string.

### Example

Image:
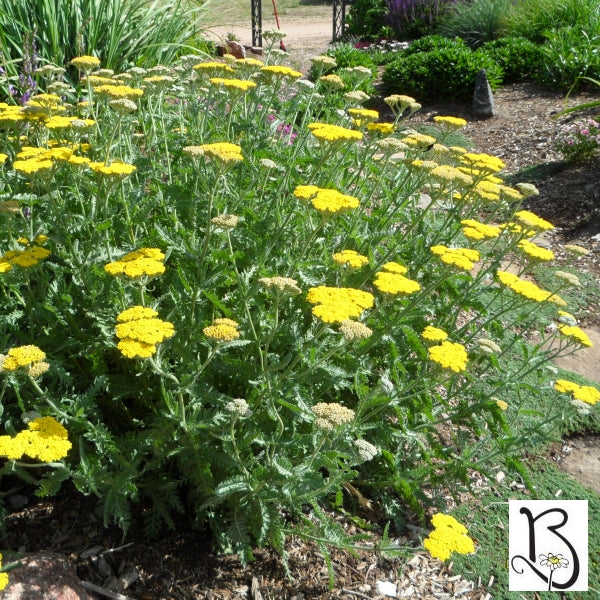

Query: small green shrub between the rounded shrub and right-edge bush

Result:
[481,37,543,83]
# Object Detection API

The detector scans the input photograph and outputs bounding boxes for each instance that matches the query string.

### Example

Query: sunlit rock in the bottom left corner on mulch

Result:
[0,552,94,600]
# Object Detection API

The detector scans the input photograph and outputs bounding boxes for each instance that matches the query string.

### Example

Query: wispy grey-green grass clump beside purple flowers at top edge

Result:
[437,0,512,48]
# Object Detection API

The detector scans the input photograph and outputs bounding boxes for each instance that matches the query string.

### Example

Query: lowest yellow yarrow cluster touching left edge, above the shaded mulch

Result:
[0,417,71,462]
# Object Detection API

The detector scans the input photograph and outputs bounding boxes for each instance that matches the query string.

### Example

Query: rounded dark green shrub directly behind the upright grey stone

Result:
[382,42,502,102]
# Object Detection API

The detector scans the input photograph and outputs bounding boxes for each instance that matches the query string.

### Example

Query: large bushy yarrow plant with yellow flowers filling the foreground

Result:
[0,50,597,561]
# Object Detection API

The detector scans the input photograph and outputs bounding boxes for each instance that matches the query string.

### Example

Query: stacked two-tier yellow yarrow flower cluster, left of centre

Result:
[115,306,175,358]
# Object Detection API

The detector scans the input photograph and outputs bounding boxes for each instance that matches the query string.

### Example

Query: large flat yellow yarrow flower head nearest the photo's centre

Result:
[306,285,375,323]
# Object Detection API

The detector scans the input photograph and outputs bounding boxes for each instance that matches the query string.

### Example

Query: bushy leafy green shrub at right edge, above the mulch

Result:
[536,27,600,92]
